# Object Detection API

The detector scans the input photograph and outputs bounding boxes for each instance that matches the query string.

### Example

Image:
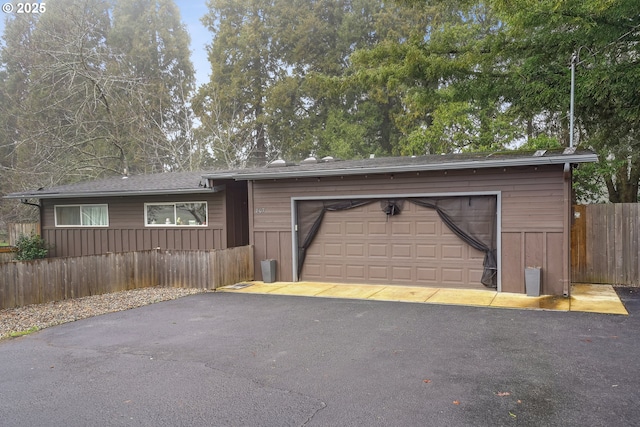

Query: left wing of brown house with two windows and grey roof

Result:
[5,172,249,257]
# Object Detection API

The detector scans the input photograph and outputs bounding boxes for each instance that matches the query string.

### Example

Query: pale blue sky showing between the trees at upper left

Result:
[0,0,211,86]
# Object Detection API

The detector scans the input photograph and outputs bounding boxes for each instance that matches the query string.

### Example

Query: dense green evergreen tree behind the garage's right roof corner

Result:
[494,0,640,203]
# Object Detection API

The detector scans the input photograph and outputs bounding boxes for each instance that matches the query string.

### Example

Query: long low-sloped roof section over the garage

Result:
[203,149,598,181]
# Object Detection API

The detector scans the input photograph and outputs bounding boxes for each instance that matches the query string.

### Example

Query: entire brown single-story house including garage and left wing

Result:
[7,149,597,295]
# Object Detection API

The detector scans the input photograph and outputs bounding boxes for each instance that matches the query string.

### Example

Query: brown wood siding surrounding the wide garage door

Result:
[249,165,566,294]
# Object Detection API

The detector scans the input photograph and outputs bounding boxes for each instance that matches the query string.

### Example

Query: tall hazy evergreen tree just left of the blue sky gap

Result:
[107,0,196,172]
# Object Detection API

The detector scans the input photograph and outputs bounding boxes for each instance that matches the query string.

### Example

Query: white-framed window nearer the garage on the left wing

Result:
[144,202,208,227]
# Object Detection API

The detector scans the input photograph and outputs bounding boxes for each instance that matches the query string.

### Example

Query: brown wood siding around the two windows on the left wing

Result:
[42,192,227,257]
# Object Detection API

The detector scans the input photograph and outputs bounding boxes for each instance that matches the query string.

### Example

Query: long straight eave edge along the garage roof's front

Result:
[211,154,598,181]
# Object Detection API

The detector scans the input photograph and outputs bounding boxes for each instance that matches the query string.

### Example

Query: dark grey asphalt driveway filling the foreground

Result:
[0,290,640,427]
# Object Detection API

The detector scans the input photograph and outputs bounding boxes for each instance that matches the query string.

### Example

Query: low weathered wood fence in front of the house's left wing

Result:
[0,246,254,309]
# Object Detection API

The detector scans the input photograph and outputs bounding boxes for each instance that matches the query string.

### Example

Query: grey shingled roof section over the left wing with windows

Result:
[5,172,216,199]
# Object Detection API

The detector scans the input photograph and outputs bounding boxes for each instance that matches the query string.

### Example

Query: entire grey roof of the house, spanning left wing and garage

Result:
[5,149,598,199]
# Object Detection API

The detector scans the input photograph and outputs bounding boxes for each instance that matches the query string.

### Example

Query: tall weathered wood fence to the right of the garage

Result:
[571,203,640,285]
